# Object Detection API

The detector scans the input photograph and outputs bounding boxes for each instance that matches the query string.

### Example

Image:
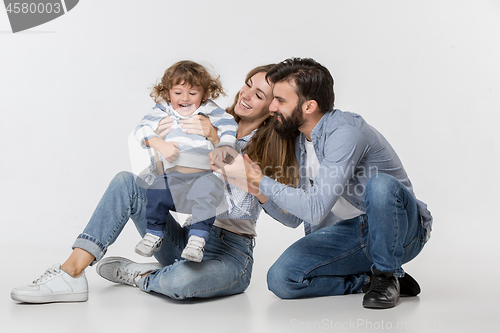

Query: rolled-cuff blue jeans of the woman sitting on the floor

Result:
[73,172,253,299]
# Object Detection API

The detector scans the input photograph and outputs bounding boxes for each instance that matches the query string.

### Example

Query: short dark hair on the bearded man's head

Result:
[266,58,335,113]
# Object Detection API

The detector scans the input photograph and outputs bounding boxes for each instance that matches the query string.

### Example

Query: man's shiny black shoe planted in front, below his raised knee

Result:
[363,268,399,309]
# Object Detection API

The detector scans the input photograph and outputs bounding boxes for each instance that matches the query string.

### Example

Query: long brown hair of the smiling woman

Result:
[226,64,299,186]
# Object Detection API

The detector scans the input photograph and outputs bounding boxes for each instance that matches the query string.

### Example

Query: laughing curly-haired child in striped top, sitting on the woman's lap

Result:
[135,61,238,262]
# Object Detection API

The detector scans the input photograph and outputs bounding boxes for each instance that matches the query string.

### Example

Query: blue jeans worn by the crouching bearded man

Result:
[267,174,426,298]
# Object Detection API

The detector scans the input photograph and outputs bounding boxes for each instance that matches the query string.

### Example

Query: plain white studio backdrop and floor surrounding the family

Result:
[0,0,500,332]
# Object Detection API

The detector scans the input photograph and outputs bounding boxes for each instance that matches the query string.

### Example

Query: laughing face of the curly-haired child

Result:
[168,84,205,117]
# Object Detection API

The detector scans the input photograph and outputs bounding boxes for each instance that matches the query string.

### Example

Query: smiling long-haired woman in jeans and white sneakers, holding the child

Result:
[11,65,295,303]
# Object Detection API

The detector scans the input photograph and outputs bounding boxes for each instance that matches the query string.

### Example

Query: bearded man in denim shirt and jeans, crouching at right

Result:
[210,58,432,308]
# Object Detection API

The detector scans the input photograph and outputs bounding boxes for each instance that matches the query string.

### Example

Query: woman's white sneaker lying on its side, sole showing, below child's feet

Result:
[95,257,163,288]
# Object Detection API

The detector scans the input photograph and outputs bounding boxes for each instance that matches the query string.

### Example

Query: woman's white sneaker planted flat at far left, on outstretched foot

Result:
[10,264,89,303]
